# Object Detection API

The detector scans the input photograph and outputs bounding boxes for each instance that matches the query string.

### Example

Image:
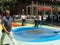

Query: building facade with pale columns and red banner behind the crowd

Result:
[17,0,60,15]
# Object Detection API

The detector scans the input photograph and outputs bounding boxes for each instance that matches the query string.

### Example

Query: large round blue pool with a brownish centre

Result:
[12,27,60,42]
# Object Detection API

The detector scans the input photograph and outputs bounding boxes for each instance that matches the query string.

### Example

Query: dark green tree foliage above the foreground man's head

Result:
[0,0,16,11]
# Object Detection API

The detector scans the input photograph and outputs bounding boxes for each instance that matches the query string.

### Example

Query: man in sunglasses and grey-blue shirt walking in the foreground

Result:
[0,10,16,45]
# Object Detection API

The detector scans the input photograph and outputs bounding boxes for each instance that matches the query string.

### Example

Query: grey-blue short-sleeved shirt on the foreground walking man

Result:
[2,16,12,32]
